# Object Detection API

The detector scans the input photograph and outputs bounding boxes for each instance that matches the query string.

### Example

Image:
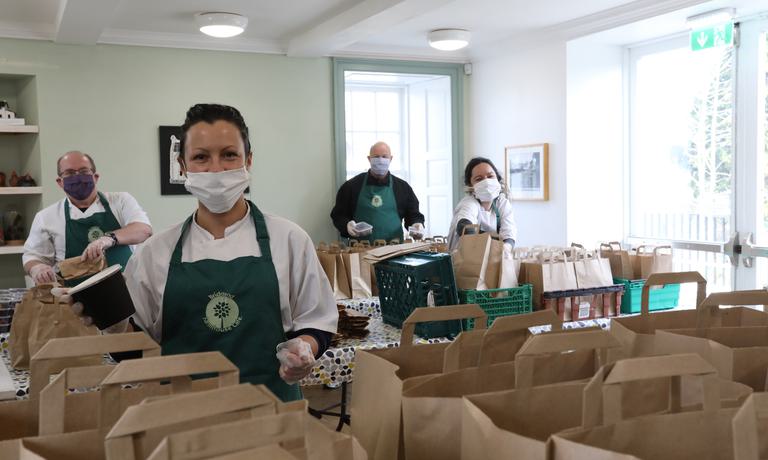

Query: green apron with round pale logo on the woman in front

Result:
[162,201,302,401]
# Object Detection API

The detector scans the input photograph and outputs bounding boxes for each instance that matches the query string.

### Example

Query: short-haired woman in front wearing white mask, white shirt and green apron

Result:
[64,104,338,401]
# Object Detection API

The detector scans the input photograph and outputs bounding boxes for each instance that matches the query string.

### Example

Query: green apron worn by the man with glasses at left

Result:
[64,193,133,286]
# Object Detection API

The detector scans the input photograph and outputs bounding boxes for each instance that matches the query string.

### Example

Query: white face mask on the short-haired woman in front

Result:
[184,167,251,214]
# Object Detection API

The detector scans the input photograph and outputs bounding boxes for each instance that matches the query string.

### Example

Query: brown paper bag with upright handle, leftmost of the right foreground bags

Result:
[350,304,487,460]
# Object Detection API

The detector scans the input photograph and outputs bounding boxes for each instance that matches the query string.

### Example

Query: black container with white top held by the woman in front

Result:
[69,265,136,330]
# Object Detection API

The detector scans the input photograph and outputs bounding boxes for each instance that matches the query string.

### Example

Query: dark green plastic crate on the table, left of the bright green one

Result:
[374,252,461,339]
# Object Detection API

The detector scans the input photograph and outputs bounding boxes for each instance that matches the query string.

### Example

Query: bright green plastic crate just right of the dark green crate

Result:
[459,284,533,331]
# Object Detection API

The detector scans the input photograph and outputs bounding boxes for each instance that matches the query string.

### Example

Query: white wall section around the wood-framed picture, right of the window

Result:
[472,42,568,246]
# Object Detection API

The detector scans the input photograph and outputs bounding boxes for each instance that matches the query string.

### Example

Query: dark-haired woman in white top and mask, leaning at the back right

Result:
[448,157,517,250]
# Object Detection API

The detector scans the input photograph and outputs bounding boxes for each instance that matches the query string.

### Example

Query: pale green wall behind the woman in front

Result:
[0,39,336,284]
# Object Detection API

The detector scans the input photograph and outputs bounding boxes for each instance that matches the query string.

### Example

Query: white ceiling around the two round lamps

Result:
[0,0,766,62]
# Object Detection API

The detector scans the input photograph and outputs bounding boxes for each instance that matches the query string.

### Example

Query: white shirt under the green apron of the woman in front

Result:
[125,208,339,343]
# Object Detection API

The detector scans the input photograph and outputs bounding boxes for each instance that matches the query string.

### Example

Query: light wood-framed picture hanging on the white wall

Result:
[504,144,549,201]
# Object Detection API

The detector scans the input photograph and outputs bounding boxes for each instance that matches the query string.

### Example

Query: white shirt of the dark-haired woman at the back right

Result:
[448,193,517,251]
